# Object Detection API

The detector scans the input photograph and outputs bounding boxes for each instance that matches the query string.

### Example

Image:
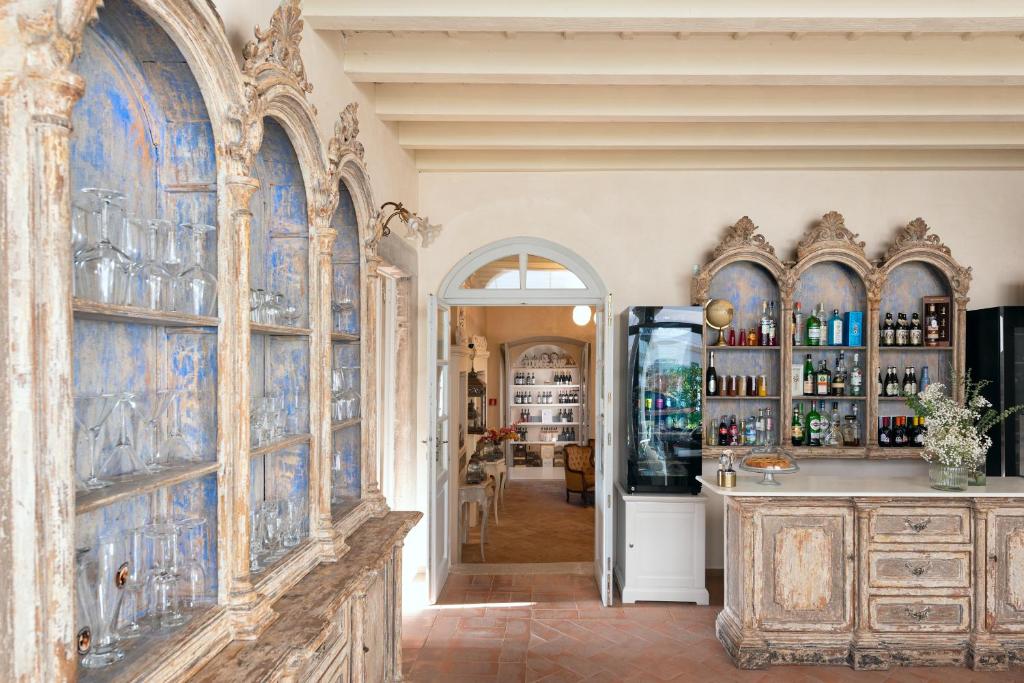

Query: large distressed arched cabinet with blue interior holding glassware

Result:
[0,0,419,681]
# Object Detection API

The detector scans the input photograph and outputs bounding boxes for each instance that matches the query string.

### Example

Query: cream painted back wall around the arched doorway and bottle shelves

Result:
[419,170,1024,567]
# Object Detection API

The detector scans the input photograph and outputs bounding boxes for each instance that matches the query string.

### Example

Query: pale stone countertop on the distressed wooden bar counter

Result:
[697,470,1024,499]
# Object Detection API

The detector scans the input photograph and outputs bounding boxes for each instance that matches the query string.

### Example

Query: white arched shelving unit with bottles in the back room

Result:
[502,337,590,467]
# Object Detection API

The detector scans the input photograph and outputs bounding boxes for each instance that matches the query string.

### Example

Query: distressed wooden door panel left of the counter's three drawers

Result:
[754,507,853,632]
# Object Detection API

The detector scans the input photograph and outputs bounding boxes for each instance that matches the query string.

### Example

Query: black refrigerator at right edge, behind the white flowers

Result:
[967,306,1024,476]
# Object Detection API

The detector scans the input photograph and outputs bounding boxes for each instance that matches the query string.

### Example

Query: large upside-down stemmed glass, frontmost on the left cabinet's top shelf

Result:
[75,187,131,304]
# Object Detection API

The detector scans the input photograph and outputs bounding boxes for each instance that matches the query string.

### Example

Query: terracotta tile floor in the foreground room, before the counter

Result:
[402,574,1024,683]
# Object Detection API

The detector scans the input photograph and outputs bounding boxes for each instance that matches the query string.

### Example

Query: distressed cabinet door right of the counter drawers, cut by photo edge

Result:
[986,508,1024,633]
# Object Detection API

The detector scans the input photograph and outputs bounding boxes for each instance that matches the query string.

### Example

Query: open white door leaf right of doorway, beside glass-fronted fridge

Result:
[594,295,615,607]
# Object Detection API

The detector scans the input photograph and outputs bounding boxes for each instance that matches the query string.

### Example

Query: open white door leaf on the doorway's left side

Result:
[427,294,452,603]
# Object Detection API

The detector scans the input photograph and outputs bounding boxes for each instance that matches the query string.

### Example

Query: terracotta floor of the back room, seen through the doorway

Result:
[462,481,594,563]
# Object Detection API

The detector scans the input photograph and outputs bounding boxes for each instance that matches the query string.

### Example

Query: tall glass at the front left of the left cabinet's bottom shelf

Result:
[78,536,126,669]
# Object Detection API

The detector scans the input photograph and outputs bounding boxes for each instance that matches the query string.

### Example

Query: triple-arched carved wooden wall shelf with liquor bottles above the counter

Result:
[693,211,971,458]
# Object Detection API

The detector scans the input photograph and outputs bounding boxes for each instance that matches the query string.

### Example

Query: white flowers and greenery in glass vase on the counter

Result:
[906,372,1024,490]
